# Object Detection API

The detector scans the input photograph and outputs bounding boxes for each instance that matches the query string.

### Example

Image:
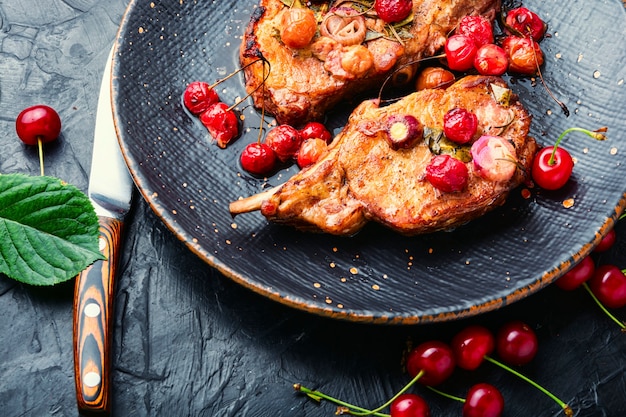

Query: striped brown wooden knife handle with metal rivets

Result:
[74,216,123,416]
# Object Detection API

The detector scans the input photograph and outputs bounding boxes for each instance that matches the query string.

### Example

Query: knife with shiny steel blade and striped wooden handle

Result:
[73,44,133,416]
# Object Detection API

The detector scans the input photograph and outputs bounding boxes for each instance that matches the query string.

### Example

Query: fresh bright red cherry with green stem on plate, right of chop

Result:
[531,146,574,190]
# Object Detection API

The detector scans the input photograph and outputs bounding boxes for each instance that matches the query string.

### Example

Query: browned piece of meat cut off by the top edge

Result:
[240,0,500,126]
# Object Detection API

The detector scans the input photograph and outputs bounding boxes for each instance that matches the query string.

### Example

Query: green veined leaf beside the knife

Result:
[0,174,104,285]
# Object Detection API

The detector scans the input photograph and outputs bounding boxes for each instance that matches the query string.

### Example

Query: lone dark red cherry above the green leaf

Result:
[15,104,61,145]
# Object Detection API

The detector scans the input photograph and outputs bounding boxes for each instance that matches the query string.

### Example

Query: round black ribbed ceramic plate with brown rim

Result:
[113,0,626,324]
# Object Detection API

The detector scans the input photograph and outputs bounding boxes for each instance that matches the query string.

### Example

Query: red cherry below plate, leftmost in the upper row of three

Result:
[406,341,455,386]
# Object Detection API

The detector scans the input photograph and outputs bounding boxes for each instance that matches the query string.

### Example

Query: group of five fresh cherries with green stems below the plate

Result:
[294,321,573,417]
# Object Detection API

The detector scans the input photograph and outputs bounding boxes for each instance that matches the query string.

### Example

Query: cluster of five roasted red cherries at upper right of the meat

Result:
[445,7,547,76]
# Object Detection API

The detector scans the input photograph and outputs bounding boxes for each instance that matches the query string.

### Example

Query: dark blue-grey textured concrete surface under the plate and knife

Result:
[0,0,626,417]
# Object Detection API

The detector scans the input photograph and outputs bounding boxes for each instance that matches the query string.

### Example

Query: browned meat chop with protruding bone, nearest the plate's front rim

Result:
[230,76,537,235]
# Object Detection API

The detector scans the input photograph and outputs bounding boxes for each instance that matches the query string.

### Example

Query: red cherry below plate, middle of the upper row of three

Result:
[450,325,495,371]
